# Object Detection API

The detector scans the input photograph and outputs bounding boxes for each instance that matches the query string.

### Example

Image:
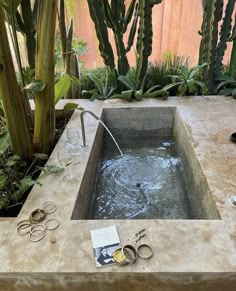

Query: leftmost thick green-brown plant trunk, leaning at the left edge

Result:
[0,1,33,158]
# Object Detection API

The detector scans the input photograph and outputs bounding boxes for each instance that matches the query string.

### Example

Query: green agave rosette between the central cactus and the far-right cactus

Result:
[162,64,207,96]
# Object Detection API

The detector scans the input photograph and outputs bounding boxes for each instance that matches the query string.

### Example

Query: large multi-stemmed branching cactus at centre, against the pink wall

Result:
[88,0,162,80]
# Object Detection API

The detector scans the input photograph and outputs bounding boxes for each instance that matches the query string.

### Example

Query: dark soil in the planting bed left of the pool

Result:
[0,112,72,217]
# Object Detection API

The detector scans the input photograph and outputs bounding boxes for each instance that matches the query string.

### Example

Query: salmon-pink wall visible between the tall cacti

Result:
[75,0,230,68]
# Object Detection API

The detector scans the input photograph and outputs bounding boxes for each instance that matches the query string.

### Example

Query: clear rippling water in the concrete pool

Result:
[90,137,193,219]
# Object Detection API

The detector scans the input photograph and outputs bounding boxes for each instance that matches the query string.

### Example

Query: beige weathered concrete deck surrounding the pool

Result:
[0,96,236,291]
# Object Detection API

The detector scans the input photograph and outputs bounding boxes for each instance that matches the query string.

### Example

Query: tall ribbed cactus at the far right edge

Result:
[199,0,235,94]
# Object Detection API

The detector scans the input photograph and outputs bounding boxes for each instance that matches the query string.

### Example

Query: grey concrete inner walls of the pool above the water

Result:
[71,107,220,220]
